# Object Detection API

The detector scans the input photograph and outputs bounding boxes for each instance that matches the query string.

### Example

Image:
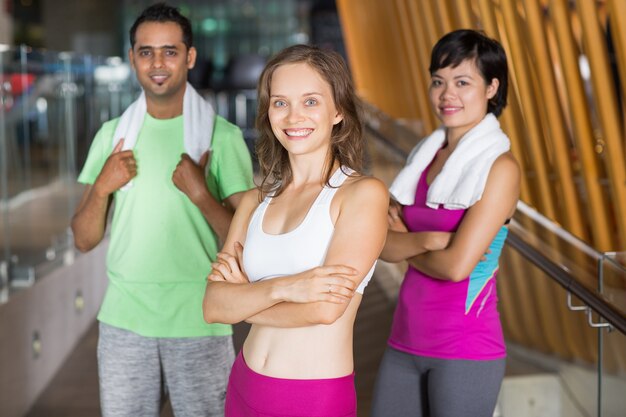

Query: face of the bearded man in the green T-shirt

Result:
[128,22,196,111]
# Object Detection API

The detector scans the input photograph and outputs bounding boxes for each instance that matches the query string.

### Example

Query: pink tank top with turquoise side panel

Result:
[389,167,507,360]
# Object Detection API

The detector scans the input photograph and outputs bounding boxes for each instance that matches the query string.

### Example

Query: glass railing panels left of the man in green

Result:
[0,47,137,302]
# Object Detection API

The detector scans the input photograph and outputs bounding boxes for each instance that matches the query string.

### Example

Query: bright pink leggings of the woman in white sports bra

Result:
[224,352,356,417]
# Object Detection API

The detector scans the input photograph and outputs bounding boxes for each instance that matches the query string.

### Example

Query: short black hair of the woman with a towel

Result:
[428,29,509,116]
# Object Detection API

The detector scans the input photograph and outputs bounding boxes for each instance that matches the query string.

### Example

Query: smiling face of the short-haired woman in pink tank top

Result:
[429,59,499,140]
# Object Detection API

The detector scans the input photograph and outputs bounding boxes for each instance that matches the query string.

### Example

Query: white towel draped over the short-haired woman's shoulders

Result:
[389,113,511,209]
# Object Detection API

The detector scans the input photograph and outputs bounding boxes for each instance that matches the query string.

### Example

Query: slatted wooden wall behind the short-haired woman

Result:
[337,0,626,251]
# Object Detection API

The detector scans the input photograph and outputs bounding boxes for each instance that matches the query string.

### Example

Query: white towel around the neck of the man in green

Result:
[112,83,215,190]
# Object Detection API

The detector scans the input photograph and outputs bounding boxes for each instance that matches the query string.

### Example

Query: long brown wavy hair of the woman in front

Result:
[256,45,363,196]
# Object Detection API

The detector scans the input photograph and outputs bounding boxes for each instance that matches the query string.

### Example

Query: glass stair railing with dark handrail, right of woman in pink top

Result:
[500,203,626,416]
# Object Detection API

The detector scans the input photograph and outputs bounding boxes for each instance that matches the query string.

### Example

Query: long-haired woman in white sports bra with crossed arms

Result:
[204,45,389,417]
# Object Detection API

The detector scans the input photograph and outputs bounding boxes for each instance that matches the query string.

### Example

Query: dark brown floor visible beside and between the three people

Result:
[26,280,393,417]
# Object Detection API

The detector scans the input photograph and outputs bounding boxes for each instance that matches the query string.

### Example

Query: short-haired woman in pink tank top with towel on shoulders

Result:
[372,30,520,417]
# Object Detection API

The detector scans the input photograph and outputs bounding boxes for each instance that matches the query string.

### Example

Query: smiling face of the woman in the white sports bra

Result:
[268,63,343,158]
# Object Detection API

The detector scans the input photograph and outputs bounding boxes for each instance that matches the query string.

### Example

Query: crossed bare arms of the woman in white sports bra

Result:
[203,178,388,327]
